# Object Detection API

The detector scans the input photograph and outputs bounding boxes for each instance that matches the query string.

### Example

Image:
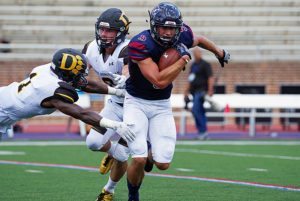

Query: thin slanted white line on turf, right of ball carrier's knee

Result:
[175,148,300,161]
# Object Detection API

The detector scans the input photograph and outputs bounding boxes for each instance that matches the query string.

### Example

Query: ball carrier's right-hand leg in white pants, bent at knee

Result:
[149,102,176,170]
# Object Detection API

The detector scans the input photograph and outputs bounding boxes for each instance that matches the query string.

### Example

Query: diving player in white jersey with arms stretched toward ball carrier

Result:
[0,48,134,141]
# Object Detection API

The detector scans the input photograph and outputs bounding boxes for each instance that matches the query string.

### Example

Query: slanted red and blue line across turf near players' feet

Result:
[0,160,300,192]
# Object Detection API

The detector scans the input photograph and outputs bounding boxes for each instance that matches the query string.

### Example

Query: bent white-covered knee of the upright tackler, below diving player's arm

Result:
[85,129,108,151]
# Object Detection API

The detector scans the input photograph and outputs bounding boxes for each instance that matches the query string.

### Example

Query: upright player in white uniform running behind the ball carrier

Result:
[82,8,130,201]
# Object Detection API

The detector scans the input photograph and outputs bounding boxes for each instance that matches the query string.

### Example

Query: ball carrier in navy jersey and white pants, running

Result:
[123,2,229,201]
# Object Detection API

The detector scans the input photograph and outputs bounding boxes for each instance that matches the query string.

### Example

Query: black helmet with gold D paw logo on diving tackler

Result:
[51,48,88,89]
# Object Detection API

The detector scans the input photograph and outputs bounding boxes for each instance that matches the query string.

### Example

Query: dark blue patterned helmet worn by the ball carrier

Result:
[149,2,183,47]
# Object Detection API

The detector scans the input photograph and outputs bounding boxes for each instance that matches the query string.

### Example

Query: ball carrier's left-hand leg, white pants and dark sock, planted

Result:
[124,97,148,201]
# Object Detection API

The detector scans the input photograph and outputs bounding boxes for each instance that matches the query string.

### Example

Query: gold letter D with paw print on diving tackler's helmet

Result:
[60,53,84,75]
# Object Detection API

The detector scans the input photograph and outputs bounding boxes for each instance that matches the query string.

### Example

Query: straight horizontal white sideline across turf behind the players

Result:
[0,140,300,147]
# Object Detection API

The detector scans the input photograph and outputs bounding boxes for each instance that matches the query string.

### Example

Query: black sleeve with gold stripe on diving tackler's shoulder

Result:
[53,82,79,103]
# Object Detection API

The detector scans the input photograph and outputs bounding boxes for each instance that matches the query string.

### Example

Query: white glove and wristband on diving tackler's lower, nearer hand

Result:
[99,117,135,142]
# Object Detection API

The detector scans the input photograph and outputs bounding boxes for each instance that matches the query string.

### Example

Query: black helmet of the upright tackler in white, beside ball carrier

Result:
[95,8,131,51]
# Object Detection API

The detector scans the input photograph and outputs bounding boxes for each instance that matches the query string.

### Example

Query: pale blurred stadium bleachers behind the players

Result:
[0,0,300,62]
